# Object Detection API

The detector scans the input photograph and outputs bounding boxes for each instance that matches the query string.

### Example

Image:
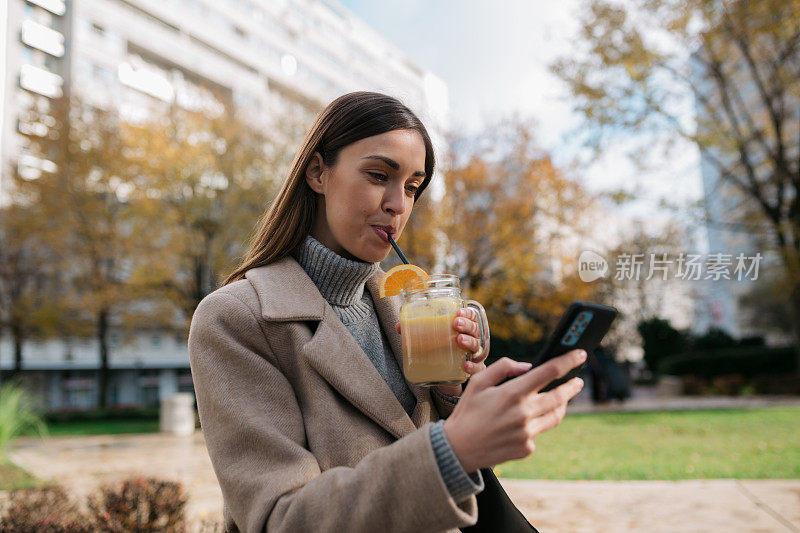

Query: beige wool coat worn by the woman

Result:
[189,257,478,533]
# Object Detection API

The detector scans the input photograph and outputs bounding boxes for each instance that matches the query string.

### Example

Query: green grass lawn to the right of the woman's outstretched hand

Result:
[495,408,800,480]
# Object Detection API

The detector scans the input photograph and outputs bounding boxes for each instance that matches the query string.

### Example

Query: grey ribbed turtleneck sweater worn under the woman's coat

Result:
[292,236,484,502]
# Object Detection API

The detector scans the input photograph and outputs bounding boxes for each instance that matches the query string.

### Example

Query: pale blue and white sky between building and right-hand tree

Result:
[340,0,703,249]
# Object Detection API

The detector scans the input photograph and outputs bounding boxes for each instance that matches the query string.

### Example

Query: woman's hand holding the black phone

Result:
[444,350,586,473]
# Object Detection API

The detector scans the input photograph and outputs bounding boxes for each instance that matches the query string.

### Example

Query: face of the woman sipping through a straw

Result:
[306,130,425,263]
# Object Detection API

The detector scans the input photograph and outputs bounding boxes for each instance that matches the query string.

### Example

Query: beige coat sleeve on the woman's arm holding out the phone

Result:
[189,292,477,532]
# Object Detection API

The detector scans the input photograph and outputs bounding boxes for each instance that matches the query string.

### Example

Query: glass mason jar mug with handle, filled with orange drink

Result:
[400,274,489,386]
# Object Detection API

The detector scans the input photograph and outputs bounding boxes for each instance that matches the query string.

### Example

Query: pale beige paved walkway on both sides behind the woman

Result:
[7,432,800,533]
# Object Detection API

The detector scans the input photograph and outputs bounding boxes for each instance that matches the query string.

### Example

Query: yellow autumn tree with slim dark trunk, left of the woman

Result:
[14,97,138,408]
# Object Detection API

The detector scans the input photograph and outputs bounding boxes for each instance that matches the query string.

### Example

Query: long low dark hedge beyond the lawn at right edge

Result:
[659,346,797,377]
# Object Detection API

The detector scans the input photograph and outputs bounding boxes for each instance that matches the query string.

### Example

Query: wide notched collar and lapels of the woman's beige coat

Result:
[245,257,431,438]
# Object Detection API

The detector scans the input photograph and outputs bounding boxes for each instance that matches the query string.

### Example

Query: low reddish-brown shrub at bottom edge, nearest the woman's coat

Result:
[89,477,187,533]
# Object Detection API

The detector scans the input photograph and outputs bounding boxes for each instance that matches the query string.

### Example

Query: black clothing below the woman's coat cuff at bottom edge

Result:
[461,468,538,533]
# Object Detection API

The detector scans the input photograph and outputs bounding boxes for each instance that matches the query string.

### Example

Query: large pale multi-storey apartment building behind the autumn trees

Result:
[0,0,448,409]
